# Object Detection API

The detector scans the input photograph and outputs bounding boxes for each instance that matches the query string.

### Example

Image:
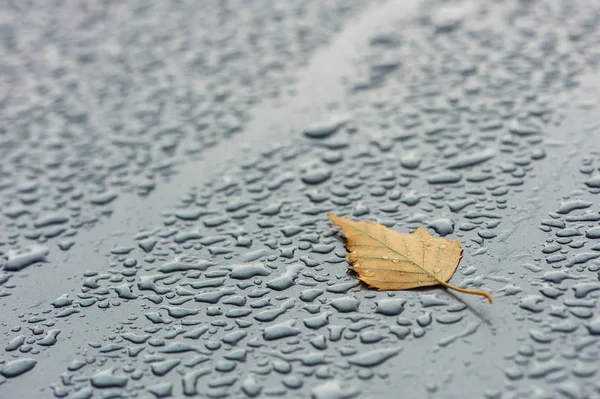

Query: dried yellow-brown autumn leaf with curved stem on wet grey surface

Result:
[327,213,492,303]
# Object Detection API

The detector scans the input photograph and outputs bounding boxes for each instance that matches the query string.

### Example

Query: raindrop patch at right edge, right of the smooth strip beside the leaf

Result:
[496,157,600,399]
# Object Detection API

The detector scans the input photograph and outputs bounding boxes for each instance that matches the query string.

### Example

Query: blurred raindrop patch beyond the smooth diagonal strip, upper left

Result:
[0,0,369,260]
